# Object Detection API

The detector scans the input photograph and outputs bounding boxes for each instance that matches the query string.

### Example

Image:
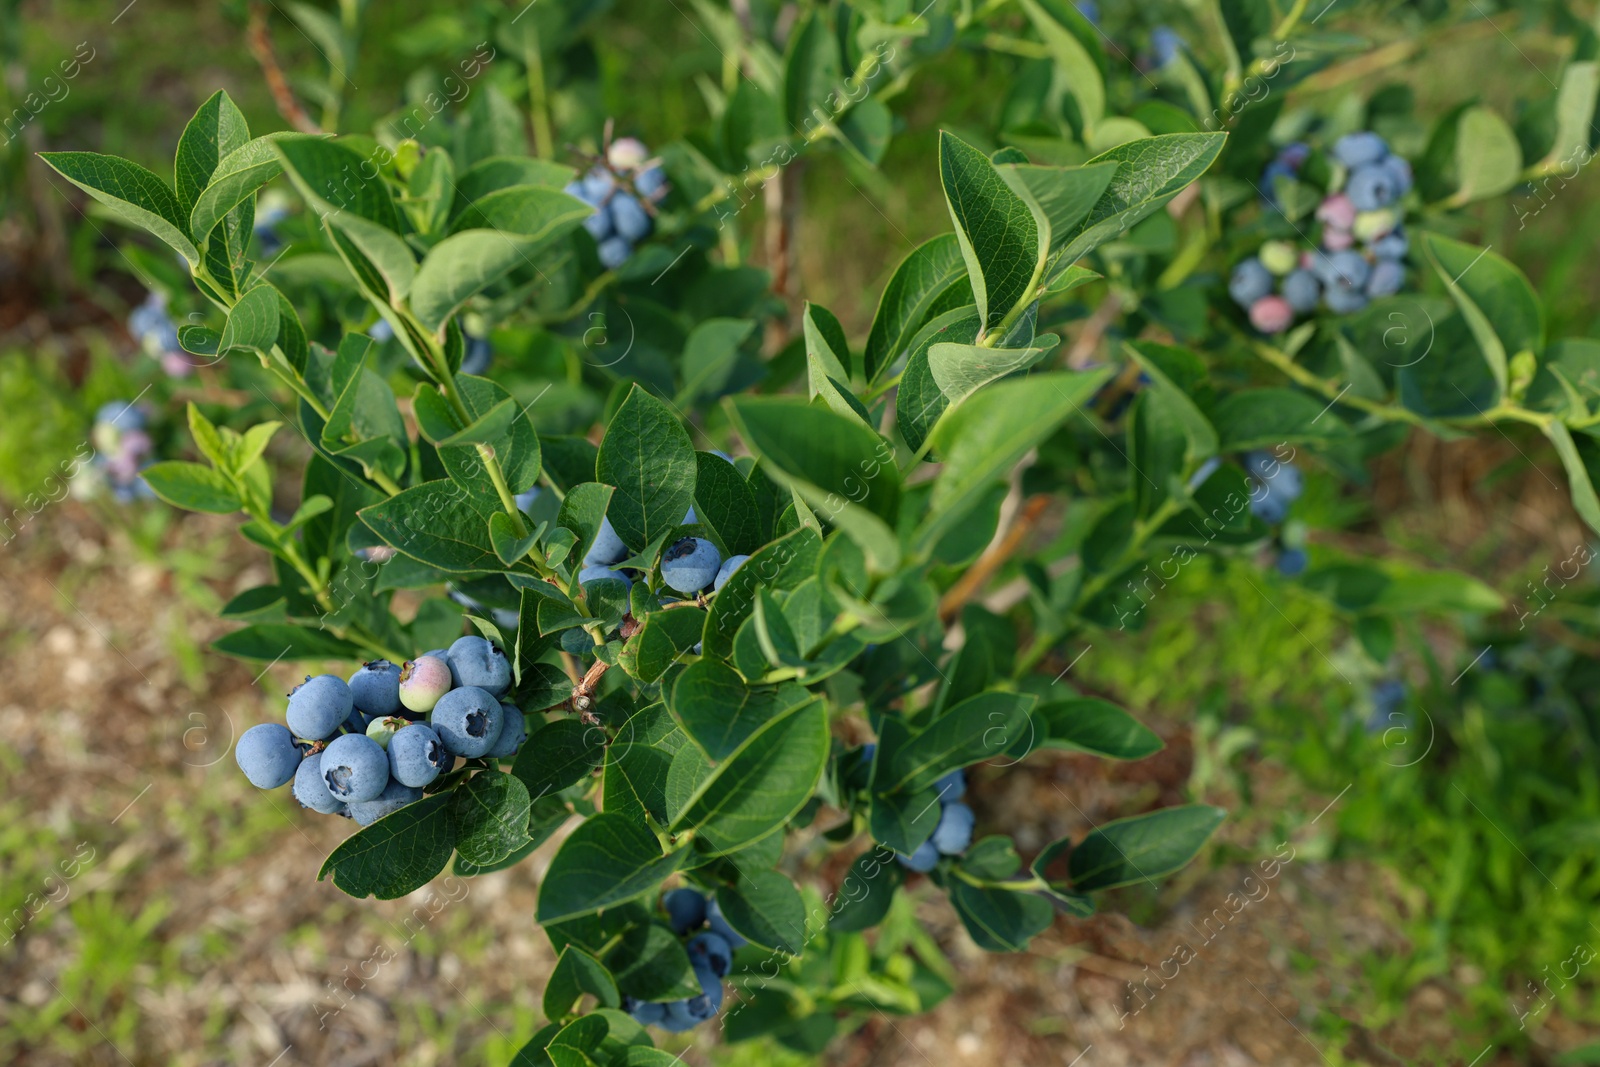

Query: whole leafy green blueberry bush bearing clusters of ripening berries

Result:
[28,0,1600,1064]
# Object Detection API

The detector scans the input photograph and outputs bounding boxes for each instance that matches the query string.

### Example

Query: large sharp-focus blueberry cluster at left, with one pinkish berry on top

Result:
[234,637,528,825]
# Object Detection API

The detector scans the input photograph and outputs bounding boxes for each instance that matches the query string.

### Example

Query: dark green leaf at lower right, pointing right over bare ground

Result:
[1067,805,1227,893]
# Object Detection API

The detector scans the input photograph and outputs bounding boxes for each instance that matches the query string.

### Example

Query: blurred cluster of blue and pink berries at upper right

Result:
[1227,131,1411,333]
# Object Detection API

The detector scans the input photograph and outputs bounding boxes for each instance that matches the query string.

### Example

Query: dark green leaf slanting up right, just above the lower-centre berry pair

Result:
[872,693,1038,793]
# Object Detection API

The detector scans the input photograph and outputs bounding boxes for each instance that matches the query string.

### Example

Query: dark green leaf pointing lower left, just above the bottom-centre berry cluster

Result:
[536,813,690,925]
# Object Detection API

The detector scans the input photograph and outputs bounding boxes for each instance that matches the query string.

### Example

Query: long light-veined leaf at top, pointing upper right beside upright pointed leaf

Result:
[1058,133,1227,264]
